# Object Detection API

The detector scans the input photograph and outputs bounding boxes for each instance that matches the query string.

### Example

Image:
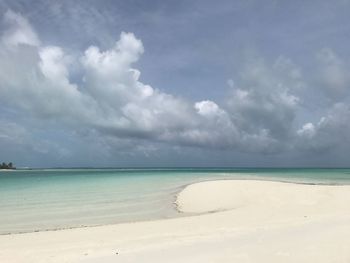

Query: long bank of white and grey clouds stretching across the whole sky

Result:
[0,10,350,167]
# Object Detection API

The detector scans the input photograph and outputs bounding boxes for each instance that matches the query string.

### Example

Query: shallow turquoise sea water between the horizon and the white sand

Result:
[0,168,350,234]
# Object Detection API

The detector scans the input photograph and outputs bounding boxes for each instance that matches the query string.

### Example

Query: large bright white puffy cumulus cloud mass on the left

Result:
[0,13,206,151]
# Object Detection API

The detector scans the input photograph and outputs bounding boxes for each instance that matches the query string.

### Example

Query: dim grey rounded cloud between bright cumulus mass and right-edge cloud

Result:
[228,57,304,151]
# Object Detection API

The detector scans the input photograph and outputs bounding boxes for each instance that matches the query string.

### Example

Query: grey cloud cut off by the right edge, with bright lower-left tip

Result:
[295,48,350,152]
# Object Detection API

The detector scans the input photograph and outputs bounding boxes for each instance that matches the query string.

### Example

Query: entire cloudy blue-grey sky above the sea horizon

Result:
[0,0,350,167]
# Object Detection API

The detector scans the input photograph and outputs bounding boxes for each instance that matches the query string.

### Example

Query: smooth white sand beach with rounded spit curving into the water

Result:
[0,180,350,263]
